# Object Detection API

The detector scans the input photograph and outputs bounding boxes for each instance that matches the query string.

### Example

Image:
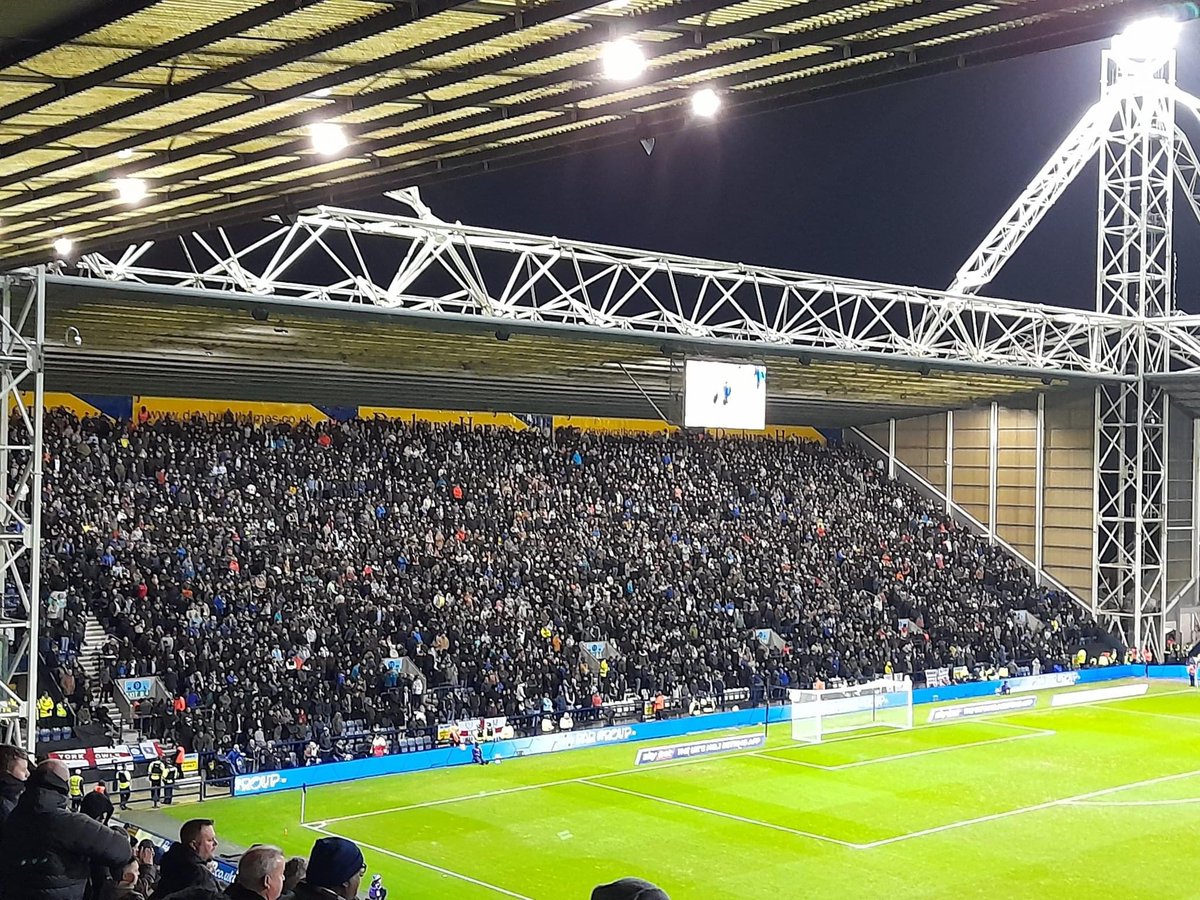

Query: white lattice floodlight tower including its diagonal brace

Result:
[952,31,1200,658]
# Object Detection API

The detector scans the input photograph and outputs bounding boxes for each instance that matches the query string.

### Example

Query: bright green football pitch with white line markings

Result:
[170,682,1200,900]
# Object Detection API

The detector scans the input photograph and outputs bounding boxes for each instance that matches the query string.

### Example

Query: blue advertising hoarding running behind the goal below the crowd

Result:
[234,666,1187,797]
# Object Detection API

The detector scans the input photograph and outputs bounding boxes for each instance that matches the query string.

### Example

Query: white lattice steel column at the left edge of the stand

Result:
[0,270,46,752]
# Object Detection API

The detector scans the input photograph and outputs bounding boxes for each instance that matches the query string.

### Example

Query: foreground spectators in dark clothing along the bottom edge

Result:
[0,745,668,900]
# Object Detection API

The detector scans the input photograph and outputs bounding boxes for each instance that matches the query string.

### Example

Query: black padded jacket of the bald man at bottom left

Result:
[0,772,133,900]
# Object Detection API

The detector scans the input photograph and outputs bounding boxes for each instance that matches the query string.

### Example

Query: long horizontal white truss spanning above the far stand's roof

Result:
[79,192,1132,377]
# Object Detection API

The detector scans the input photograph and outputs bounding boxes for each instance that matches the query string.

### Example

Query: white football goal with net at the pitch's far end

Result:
[787,678,912,744]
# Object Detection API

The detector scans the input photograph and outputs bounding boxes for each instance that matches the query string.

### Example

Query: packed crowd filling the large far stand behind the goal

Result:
[42,410,1087,751]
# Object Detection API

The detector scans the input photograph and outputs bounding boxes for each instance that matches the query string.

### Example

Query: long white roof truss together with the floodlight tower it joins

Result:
[58,38,1200,650]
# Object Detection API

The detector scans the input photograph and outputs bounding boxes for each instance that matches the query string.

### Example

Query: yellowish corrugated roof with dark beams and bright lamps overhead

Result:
[0,0,1160,268]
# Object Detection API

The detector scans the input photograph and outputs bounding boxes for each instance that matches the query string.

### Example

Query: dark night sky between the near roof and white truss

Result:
[405,30,1200,312]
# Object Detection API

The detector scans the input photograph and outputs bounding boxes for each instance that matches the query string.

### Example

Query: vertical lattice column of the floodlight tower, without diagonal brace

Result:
[1096,49,1175,659]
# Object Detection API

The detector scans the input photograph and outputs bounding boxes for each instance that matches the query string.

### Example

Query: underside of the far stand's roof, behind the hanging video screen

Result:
[47,276,1087,426]
